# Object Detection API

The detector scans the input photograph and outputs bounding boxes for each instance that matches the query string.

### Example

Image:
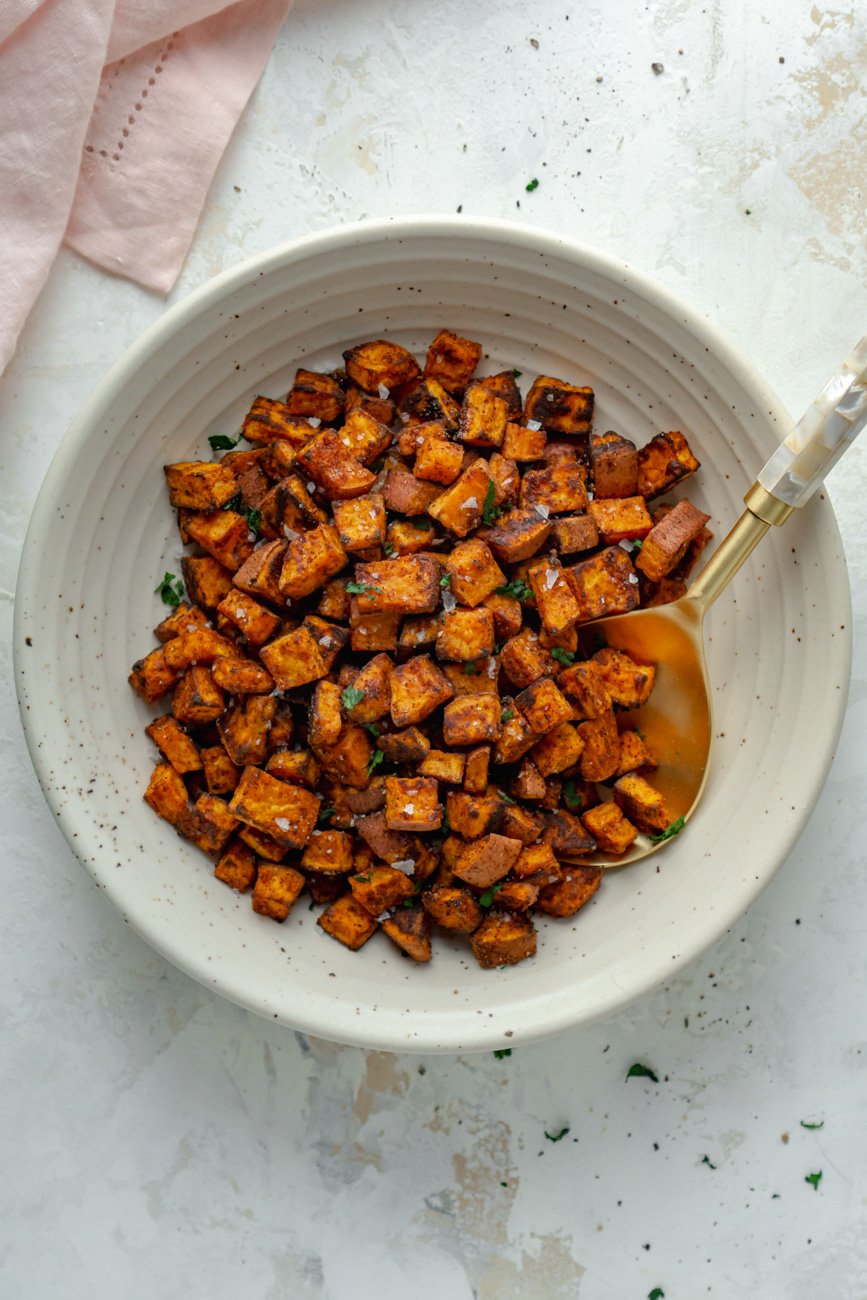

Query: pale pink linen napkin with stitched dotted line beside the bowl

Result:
[0,0,291,372]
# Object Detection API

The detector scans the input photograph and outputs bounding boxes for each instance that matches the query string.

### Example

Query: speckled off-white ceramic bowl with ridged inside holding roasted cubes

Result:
[16,217,850,1052]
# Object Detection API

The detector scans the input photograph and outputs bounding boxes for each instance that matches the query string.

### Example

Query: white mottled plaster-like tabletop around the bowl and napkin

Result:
[0,0,867,1300]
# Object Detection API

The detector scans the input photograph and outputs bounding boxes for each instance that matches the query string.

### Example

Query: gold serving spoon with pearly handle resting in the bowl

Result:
[582,337,867,867]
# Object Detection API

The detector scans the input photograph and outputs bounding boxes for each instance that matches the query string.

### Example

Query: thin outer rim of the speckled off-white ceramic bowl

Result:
[13,215,851,1053]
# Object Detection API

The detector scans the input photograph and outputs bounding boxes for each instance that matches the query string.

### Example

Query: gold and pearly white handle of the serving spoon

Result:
[686,337,867,610]
